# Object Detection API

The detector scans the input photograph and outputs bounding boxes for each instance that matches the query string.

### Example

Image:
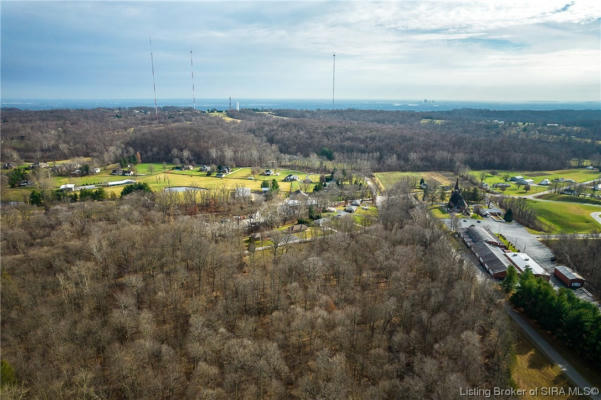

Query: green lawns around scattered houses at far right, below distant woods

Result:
[470,168,601,196]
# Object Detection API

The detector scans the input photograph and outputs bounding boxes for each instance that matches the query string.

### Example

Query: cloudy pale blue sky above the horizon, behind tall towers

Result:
[0,0,601,102]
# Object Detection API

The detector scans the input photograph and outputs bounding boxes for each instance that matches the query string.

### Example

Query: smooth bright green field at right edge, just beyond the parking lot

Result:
[528,200,601,233]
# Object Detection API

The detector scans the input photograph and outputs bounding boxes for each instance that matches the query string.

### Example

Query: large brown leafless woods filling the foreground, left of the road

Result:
[1,188,512,400]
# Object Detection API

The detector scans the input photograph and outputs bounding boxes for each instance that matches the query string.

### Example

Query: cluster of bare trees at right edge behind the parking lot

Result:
[545,234,601,296]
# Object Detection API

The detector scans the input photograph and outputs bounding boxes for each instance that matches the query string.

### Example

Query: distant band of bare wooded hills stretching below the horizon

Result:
[2,108,601,171]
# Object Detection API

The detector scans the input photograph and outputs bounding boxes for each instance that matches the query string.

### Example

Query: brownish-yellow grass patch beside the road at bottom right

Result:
[511,333,578,399]
